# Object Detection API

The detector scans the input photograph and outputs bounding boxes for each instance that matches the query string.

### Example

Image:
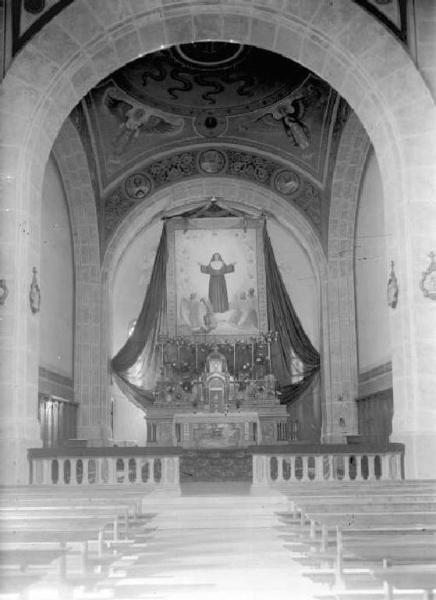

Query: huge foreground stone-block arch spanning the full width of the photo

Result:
[0,0,436,475]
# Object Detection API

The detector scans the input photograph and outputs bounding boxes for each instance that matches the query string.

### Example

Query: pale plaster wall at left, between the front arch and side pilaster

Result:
[39,157,74,386]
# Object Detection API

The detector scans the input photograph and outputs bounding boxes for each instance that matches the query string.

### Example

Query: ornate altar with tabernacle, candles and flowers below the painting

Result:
[147,337,290,449]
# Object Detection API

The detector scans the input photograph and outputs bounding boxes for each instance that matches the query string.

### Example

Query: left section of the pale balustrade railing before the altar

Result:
[29,449,180,486]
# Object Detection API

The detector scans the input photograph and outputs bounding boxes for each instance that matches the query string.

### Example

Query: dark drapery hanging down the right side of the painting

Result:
[263,223,320,404]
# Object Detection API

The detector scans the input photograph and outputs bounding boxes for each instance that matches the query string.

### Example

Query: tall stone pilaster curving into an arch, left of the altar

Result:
[53,119,107,439]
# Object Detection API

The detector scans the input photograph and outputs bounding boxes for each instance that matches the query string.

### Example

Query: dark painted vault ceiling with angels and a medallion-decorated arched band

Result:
[72,42,346,245]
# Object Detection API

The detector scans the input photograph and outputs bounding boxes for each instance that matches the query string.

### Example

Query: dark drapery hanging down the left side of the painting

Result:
[111,223,168,402]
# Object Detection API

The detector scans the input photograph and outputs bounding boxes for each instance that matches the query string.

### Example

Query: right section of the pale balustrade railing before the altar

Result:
[253,444,404,485]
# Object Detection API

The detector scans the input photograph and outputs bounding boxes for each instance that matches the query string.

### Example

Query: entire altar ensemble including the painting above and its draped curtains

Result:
[112,207,319,454]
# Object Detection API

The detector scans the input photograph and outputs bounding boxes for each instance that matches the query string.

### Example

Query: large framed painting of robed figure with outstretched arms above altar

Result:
[167,217,268,342]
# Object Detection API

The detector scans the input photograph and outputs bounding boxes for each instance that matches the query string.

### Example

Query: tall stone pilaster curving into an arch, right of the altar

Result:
[326,114,370,441]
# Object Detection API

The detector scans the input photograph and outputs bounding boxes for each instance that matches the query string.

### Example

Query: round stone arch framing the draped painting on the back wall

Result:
[102,177,331,434]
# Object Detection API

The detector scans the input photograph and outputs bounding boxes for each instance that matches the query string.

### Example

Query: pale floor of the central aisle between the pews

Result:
[55,484,328,600]
